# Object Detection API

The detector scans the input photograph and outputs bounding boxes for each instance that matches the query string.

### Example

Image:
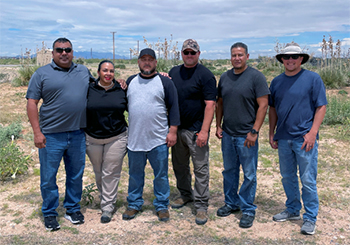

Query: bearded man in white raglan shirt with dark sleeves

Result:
[123,48,180,221]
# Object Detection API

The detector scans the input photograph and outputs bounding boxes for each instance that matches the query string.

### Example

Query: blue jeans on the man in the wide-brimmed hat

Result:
[278,139,319,222]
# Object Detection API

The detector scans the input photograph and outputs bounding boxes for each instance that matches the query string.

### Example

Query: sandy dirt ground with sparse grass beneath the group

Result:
[0,67,350,244]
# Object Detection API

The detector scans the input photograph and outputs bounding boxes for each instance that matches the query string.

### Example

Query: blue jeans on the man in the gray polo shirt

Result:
[39,130,86,217]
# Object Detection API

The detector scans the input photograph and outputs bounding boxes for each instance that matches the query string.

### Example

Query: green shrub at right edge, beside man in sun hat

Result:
[323,96,350,125]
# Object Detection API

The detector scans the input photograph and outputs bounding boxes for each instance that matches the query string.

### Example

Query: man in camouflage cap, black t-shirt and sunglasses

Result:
[169,39,216,225]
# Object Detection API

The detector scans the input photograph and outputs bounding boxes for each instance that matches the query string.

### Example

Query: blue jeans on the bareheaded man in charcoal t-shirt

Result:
[221,132,259,216]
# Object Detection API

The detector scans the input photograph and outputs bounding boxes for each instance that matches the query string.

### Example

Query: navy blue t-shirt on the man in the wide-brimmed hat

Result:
[269,69,327,141]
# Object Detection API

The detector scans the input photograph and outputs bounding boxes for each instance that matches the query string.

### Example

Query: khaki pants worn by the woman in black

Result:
[86,131,127,212]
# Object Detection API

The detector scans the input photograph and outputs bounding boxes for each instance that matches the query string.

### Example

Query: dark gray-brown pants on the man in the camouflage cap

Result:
[171,129,209,211]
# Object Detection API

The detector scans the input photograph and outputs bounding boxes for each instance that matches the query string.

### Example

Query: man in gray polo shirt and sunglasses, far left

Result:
[26,38,92,231]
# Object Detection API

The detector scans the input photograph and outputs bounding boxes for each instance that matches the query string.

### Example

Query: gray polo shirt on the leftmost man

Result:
[26,61,91,133]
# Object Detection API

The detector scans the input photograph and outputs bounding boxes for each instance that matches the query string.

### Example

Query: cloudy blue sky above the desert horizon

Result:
[0,0,350,59]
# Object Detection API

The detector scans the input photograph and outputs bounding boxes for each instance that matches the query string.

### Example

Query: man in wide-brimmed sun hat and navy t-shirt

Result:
[269,42,327,235]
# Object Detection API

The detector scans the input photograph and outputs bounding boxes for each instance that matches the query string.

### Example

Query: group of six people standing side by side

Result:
[26,38,327,234]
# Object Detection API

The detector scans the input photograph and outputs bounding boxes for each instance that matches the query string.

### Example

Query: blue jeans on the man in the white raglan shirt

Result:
[127,144,170,212]
